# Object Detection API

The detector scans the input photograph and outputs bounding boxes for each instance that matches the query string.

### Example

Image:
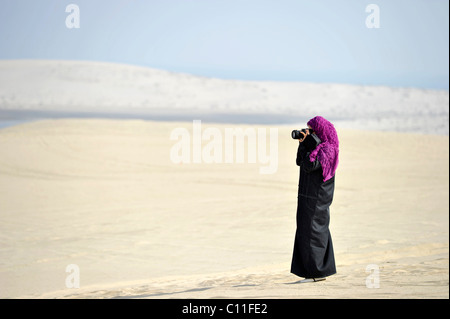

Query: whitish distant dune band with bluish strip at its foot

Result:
[0,60,449,135]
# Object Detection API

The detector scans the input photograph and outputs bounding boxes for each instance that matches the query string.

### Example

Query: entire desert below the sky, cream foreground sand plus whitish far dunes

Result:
[0,60,449,298]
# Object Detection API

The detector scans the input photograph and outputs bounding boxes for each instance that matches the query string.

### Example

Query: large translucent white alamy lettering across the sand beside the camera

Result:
[170,120,278,174]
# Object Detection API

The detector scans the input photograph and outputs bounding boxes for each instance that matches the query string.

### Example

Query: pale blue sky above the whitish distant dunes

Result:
[0,0,449,90]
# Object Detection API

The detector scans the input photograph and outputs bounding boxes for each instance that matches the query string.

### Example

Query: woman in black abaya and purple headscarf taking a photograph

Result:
[291,116,339,282]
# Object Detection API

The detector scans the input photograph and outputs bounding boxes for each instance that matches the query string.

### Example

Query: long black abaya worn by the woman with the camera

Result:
[291,143,336,278]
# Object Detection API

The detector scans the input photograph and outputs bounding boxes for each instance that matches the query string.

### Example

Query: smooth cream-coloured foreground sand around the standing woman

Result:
[0,119,449,298]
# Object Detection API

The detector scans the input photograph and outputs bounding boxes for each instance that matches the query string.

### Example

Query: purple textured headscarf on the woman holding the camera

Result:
[308,116,339,182]
